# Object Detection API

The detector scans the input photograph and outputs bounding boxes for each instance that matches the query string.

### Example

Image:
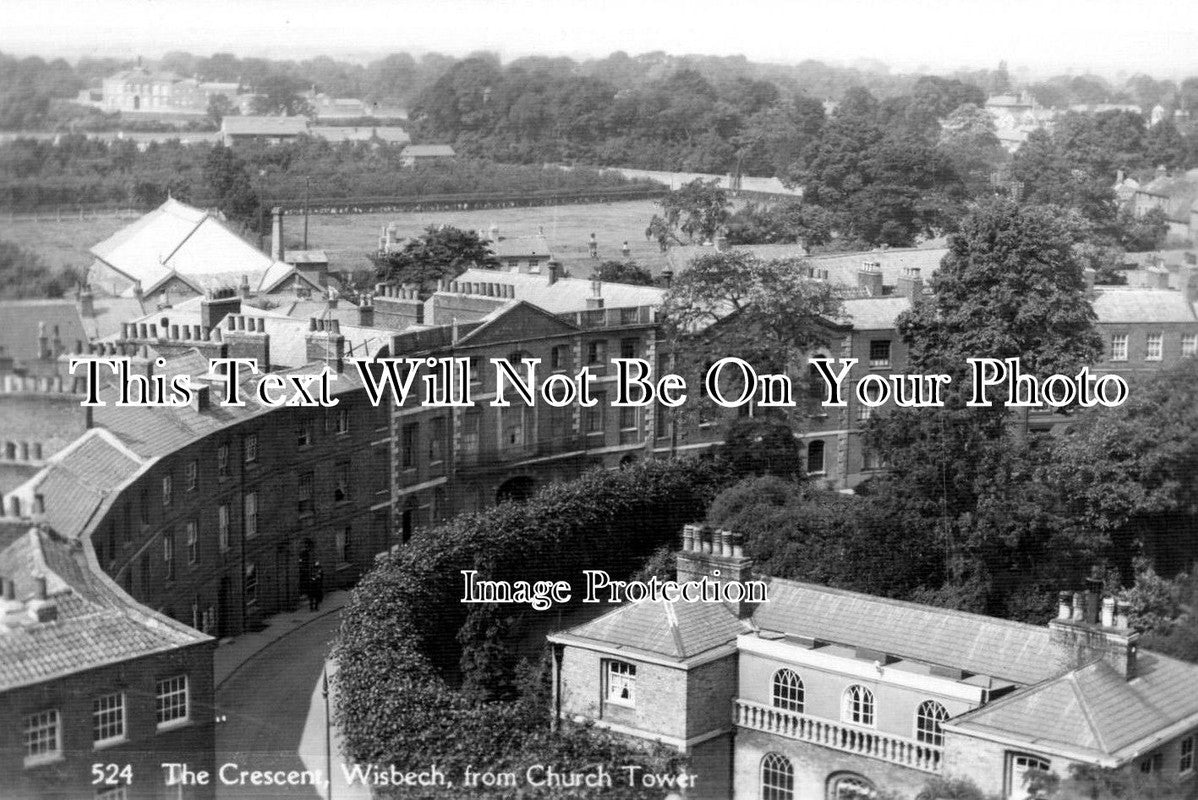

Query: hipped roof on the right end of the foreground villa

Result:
[954,650,1198,758]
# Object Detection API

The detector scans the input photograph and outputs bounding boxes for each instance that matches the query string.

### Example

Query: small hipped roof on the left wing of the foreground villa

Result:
[568,601,749,660]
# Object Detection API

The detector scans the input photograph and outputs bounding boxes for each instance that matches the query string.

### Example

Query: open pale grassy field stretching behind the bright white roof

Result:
[0,200,680,278]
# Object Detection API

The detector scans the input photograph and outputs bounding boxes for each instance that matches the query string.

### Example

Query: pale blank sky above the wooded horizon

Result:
[0,0,1198,78]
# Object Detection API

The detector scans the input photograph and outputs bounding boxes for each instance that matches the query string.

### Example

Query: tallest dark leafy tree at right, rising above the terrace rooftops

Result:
[869,199,1105,618]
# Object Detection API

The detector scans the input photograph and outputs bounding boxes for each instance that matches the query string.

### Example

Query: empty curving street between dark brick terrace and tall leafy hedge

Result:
[216,593,369,800]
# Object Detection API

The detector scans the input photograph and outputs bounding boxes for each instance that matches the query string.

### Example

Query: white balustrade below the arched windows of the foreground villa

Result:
[733,701,940,772]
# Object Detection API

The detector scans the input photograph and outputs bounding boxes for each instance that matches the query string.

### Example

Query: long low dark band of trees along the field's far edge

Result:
[0,135,641,211]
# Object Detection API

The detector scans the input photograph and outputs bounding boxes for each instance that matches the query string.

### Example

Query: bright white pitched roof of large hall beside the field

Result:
[91,198,292,296]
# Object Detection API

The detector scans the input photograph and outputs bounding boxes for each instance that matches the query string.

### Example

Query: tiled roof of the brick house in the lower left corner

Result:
[0,528,211,692]
